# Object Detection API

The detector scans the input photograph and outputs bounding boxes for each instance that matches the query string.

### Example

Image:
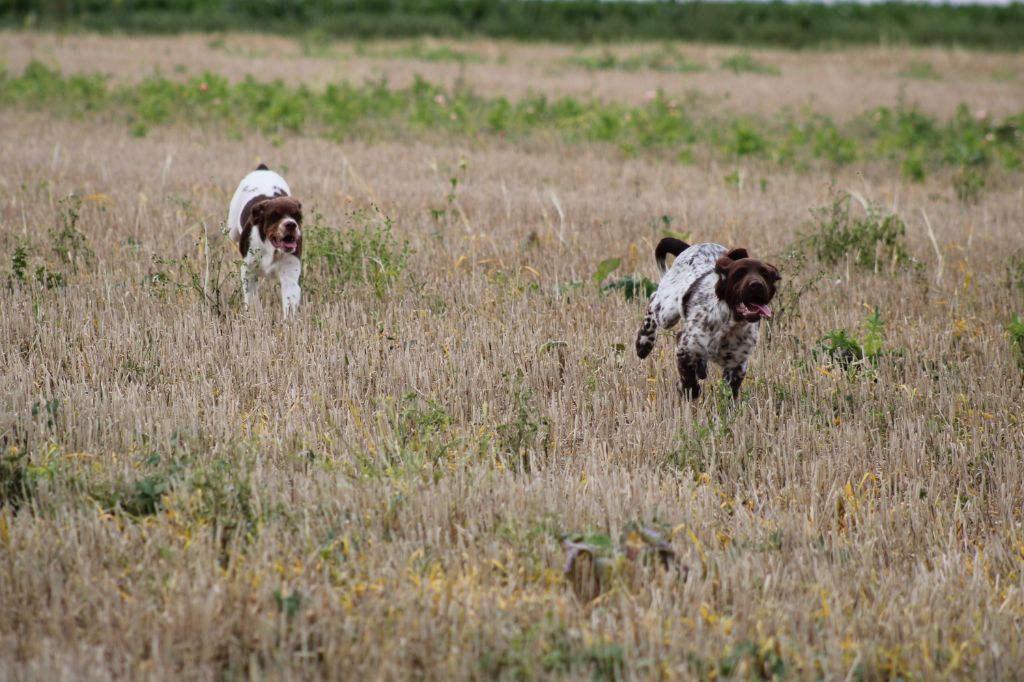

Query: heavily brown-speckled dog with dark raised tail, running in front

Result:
[637,238,781,399]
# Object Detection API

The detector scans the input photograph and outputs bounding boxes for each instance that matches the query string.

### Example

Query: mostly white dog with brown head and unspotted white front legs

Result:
[227,164,302,316]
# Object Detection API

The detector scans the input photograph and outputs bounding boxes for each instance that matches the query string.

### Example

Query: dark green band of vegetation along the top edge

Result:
[6,0,1024,49]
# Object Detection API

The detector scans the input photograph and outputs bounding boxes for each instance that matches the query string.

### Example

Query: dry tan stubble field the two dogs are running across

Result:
[0,34,1024,680]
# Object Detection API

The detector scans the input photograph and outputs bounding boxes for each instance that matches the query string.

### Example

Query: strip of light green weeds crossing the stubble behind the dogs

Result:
[0,62,1024,184]
